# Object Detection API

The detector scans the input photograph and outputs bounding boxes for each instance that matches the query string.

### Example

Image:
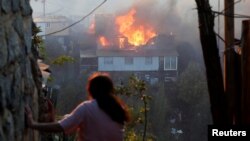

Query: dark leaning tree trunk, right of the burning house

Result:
[195,0,229,124]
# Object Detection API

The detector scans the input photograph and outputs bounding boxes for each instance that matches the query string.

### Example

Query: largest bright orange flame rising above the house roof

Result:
[115,9,156,46]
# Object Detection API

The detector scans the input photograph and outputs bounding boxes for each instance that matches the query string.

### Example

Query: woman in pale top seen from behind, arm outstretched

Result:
[26,73,129,141]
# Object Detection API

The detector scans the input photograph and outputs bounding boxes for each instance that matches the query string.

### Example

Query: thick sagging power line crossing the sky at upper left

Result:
[40,0,107,37]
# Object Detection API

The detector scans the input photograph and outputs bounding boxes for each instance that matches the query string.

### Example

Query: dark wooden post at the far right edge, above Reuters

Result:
[241,20,250,125]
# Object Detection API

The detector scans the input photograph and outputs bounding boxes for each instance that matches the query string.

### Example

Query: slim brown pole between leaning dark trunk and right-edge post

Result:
[224,0,239,124]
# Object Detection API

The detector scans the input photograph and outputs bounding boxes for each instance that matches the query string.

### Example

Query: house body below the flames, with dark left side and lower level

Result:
[81,49,178,83]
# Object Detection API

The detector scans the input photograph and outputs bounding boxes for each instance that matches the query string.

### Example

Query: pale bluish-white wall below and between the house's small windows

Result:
[98,57,159,71]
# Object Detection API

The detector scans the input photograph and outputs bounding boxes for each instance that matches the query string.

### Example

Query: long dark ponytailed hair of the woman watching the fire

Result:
[87,73,129,125]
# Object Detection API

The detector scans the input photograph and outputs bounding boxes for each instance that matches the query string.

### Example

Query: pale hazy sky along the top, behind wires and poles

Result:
[30,0,250,46]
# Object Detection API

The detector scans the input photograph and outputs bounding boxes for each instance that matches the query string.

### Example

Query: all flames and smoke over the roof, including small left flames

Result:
[90,9,157,49]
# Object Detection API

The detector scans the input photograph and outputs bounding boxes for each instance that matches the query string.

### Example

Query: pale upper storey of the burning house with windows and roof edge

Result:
[97,49,178,71]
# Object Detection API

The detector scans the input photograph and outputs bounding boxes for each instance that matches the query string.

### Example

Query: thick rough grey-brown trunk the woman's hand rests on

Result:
[0,0,41,141]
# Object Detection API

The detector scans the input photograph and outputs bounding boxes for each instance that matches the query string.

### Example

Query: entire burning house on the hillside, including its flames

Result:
[81,9,178,83]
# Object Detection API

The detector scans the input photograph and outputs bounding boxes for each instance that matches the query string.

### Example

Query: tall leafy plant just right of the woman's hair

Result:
[116,75,151,141]
